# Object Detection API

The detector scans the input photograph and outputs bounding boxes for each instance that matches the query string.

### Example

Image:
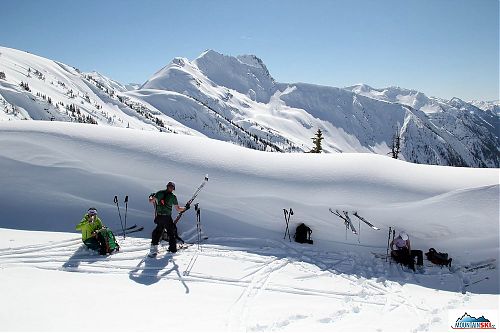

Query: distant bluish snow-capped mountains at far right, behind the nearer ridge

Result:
[346,85,500,167]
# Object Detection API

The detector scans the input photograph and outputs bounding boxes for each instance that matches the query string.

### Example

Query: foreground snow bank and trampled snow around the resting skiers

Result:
[0,121,499,331]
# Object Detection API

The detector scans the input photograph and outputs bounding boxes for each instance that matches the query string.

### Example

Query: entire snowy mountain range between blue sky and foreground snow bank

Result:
[0,48,500,167]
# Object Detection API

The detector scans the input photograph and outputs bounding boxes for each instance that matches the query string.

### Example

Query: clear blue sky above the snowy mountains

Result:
[0,0,499,100]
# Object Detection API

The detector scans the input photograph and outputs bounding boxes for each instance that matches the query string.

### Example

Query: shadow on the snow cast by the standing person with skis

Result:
[129,253,189,294]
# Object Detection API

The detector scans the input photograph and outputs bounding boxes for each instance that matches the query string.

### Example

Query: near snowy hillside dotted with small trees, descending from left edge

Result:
[0,47,202,135]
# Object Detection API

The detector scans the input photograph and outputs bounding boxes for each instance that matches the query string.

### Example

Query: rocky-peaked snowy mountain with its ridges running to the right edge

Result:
[136,50,500,167]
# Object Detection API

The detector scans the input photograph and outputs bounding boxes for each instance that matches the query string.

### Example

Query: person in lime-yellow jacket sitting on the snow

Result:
[76,207,119,255]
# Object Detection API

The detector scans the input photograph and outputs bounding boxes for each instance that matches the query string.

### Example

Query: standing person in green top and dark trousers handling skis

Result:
[149,182,190,257]
